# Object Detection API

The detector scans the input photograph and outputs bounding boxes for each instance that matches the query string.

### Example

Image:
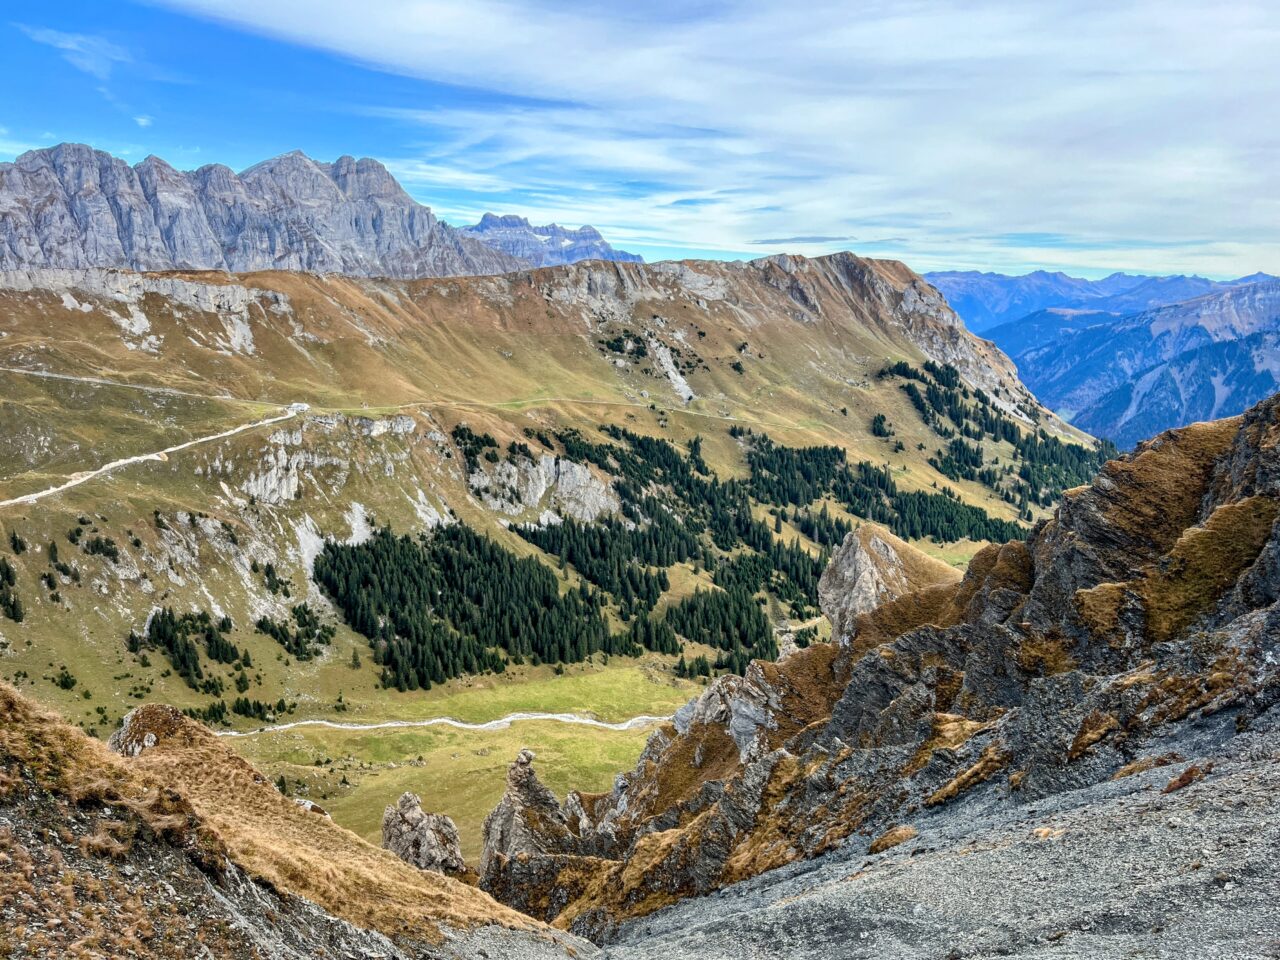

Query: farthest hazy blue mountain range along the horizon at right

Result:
[924,270,1274,332]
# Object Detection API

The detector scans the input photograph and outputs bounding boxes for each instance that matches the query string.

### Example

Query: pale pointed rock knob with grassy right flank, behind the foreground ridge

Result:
[818,524,960,640]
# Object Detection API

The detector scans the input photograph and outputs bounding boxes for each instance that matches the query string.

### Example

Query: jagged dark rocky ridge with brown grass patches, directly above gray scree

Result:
[476,397,1280,940]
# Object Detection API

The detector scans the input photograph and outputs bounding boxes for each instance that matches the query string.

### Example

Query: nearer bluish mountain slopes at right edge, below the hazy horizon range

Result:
[987,279,1280,447]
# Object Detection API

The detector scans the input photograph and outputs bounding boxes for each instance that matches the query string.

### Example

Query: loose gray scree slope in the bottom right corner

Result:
[600,718,1280,960]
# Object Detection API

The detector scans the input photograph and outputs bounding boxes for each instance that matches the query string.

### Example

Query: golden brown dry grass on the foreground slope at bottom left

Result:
[0,684,550,941]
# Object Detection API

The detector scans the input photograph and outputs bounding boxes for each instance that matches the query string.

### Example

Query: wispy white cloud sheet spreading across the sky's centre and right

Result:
[142,0,1280,274]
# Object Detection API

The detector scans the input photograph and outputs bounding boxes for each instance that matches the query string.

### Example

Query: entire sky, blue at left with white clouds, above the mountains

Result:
[0,0,1280,276]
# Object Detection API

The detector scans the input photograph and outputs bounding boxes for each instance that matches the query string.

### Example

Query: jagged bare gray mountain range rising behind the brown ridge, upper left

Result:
[0,143,527,278]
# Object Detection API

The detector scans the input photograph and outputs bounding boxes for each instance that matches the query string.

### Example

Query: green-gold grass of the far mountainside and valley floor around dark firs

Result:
[0,259,1100,849]
